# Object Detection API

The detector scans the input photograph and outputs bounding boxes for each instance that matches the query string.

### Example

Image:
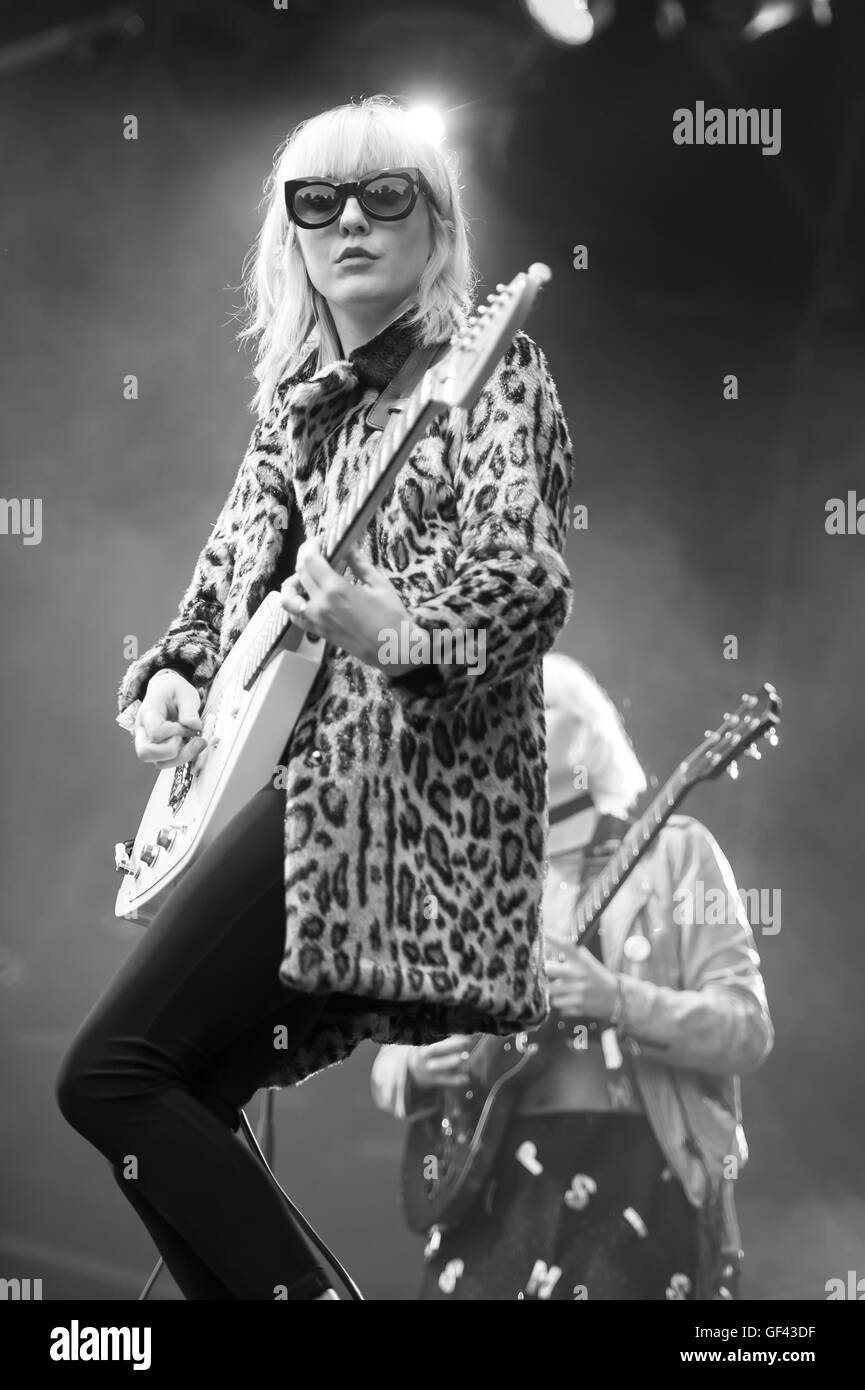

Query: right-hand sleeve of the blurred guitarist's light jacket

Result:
[620,820,775,1076]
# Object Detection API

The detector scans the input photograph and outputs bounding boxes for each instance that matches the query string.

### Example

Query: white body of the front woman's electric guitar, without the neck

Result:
[114,592,324,923]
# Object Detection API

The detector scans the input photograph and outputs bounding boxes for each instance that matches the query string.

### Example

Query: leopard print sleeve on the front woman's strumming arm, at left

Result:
[115,421,264,731]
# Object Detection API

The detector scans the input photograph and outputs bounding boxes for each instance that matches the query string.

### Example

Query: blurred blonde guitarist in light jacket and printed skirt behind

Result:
[371,653,773,1300]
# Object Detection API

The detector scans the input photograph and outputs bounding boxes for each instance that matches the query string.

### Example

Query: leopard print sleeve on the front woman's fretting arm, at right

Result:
[391,332,573,719]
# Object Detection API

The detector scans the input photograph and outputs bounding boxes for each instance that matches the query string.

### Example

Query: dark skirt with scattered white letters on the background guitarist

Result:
[417,1112,698,1301]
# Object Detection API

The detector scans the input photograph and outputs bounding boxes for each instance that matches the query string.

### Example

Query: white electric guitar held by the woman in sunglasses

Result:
[114,264,551,923]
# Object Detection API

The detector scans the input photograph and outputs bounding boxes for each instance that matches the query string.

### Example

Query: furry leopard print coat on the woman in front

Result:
[118,325,572,1087]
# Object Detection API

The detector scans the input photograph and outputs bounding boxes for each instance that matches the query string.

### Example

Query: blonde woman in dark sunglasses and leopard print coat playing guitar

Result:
[57,99,572,1300]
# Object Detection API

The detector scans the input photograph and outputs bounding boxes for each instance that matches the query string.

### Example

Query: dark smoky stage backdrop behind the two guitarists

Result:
[0,0,865,1300]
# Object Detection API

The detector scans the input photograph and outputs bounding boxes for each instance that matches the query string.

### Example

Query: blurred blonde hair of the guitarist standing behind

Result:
[544,652,648,816]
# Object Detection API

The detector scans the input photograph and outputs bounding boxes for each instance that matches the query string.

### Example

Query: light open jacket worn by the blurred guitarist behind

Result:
[371,816,773,1273]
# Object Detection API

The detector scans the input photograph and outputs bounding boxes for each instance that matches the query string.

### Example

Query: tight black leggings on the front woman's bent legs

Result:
[57,783,331,1300]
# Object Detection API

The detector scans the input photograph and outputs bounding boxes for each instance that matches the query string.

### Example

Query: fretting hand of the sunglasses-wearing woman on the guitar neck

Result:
[280,537,414,676]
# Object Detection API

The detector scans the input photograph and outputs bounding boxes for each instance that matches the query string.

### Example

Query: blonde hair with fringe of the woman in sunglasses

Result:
[238,96,476,418]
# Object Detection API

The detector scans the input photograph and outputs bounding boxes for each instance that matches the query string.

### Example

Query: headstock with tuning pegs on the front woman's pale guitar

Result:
[424,261,552,410]
